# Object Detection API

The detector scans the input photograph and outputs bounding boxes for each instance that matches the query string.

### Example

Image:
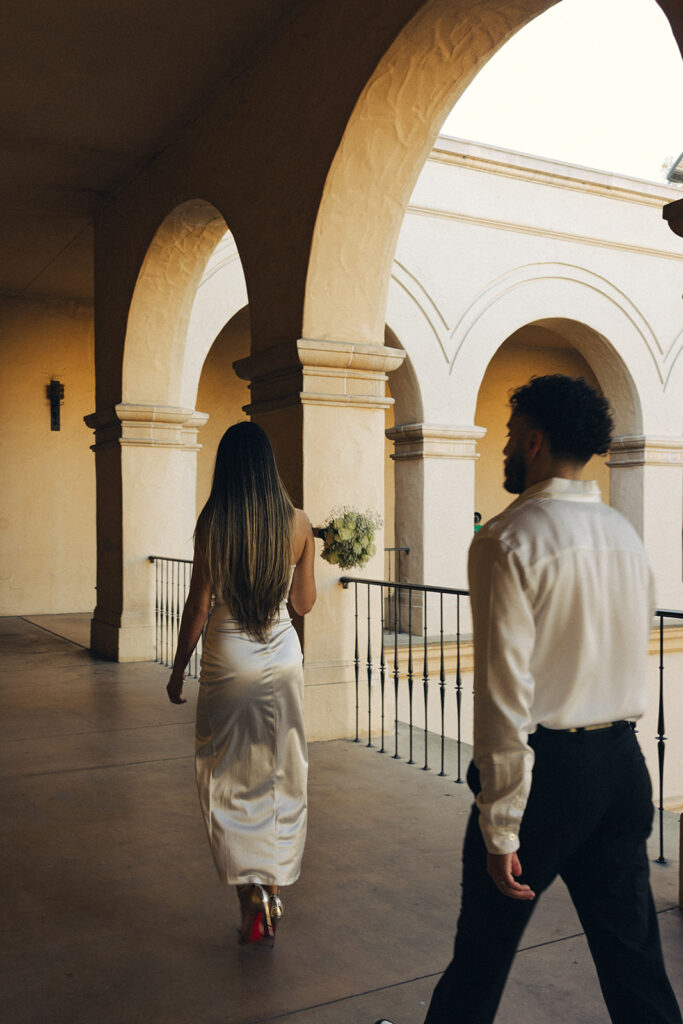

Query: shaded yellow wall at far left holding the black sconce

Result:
[0,299,95,615]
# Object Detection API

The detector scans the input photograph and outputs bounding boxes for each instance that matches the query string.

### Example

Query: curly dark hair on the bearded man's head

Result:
[510,374,614,463]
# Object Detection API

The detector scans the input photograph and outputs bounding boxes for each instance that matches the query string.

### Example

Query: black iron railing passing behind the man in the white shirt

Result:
[340,575,683,864]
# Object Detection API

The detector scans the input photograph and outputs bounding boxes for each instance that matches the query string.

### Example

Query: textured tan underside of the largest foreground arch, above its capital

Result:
[303,0,553,344]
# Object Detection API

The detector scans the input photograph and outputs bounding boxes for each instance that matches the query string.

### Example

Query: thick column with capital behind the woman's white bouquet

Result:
[234,338,404,739]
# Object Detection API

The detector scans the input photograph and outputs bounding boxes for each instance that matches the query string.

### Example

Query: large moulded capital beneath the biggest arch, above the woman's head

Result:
[232,338,405,414]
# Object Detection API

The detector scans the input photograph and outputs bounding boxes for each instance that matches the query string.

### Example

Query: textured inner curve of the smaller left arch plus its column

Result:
[87,200,233,660]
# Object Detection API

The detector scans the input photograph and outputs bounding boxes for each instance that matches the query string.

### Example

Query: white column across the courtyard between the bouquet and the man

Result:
[386,423,486,631]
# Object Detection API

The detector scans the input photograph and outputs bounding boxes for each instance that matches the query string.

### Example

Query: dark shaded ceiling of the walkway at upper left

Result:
[0,0,299,301]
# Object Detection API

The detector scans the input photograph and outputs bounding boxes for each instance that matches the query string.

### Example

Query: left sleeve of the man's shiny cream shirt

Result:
[469,532,536,854]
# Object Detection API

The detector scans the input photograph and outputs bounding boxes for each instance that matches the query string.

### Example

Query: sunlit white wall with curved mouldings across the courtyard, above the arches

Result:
[389,137,683,434]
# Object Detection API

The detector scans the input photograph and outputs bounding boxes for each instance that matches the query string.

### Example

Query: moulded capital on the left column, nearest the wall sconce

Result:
[83,402,209,452]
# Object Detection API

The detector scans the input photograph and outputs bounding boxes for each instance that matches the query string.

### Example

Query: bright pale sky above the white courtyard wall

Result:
[441,0,683,181]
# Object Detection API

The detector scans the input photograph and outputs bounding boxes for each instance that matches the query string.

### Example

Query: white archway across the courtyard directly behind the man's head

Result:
[450,264,683,607]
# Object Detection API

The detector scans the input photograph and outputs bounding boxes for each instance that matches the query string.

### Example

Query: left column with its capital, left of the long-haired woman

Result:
[86,404,208,662]
